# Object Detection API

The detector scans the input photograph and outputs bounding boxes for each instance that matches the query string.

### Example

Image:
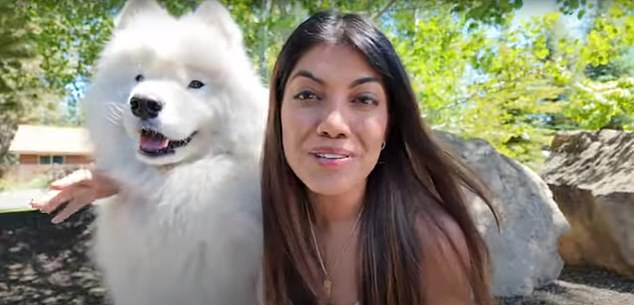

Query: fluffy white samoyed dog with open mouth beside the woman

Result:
[84,0,267,305]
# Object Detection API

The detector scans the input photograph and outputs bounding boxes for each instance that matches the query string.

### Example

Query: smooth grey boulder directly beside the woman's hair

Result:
[435,132,569,297]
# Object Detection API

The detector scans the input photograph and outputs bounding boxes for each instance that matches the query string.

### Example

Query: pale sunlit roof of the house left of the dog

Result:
[9,125,92,155]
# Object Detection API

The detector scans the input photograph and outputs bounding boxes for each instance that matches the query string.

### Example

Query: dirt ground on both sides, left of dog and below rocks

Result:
[0,210,634,305]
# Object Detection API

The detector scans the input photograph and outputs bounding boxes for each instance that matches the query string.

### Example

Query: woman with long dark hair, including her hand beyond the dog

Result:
[36,12,492,305]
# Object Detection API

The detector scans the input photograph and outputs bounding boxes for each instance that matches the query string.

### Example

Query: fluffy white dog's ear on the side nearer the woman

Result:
[194,0,242,46]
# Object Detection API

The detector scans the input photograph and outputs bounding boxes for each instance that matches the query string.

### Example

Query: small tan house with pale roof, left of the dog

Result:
[9,125,93,181]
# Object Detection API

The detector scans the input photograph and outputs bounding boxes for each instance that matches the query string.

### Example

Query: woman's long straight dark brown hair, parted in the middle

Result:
[262,12,493,305]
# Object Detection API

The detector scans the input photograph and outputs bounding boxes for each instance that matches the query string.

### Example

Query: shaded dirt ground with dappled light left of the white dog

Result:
[0,211,106,305]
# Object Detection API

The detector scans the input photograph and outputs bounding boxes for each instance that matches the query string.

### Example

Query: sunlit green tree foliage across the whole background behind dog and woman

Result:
[0,0,634,171]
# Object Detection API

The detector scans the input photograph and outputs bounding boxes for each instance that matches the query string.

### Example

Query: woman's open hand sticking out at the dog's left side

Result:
[31,169,118,223]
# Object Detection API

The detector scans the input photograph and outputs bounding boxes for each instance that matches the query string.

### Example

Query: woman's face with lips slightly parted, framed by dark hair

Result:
[281,43,388,196]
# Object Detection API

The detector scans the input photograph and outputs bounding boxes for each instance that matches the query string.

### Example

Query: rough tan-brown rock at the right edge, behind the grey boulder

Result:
[542,130,634,277]
